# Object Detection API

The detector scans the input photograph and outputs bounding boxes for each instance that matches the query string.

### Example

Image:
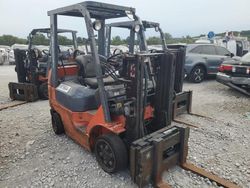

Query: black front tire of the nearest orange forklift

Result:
[95,134,128,173]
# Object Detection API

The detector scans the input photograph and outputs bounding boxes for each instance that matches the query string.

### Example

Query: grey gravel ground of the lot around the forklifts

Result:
[0,66,250,188]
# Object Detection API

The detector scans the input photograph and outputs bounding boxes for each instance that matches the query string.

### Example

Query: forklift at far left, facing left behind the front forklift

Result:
[8,28,78,102]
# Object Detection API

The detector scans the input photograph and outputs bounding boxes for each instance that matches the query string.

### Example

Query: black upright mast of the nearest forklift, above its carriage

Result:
[122,52,175,145]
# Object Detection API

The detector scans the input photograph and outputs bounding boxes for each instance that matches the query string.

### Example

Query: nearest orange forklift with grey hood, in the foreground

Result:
[48,1,238,187]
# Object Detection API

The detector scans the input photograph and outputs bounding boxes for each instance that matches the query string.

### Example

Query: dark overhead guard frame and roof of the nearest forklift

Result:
[48,1,138,122]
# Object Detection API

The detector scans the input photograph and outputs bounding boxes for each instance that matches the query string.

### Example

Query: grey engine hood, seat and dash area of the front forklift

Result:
[56,54,129,115]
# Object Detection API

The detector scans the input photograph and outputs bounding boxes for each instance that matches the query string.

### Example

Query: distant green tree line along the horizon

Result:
[0,30,250,46]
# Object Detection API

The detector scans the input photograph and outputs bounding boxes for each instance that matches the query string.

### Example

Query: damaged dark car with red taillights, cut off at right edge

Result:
[216,52,250,96]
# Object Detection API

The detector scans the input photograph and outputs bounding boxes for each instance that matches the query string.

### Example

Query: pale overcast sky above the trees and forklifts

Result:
[0,0,250,38]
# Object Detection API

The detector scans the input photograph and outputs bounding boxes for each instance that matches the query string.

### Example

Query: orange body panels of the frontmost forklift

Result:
[48,65,153,150]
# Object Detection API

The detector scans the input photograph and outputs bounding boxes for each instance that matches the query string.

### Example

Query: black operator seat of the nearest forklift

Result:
[76,54,115,89]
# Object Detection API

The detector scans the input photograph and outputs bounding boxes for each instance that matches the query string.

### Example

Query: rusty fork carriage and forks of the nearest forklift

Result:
[130,124,238,188]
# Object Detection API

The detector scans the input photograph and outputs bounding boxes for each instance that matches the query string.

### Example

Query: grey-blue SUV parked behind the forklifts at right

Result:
[185,44,234,83]
